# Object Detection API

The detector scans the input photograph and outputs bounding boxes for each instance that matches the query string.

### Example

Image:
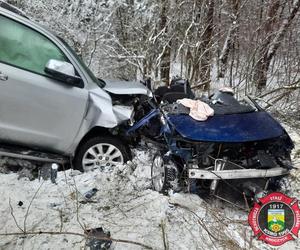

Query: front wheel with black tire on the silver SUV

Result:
[74,136,131,172]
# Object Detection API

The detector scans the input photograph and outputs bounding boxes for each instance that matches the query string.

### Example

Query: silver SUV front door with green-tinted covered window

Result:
[0,15,88,153]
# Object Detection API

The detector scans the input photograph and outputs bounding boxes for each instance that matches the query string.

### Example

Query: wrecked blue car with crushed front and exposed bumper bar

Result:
[126,80,294,201]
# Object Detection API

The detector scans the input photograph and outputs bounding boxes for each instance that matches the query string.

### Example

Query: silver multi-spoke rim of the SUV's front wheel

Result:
[82,143,124,172]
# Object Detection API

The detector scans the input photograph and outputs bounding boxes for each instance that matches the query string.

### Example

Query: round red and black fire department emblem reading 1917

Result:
[248,192,300,246]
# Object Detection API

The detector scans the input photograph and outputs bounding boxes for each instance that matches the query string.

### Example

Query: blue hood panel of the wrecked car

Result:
[169,111,285,143]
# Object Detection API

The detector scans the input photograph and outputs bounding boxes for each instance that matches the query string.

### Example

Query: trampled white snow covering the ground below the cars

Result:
[0,129,300,250]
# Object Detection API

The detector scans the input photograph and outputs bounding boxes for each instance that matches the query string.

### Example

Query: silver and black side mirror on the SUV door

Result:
[45,59,83,87]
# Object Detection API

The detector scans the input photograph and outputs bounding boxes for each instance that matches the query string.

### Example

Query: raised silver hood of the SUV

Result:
[104,80,152,97]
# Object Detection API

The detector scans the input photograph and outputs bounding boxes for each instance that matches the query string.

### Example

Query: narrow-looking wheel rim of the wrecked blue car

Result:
[151,156,165,192]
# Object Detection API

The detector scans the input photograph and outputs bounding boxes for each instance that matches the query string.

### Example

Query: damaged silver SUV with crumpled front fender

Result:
[0,7,151,171]
